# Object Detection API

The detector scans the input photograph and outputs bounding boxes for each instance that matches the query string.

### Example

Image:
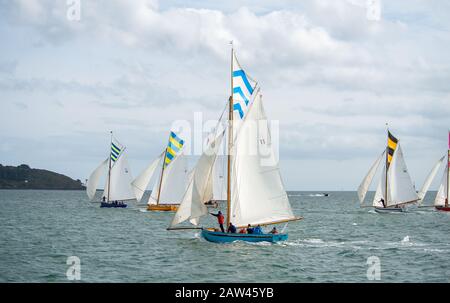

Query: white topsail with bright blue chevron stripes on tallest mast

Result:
[233,52,257,119]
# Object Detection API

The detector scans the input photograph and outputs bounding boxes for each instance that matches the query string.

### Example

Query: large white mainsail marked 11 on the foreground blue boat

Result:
[230,93,296,226]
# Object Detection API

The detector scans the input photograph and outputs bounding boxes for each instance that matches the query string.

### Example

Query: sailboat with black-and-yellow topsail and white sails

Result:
[358,130,420,213]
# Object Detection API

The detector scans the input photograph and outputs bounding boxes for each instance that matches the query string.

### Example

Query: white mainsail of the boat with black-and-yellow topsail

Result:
[386,142,419,206]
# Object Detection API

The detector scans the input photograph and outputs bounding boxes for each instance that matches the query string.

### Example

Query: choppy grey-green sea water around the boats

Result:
[0,190,450,282]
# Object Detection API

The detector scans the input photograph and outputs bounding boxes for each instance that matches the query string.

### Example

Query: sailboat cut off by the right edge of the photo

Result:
[419,132,450,211]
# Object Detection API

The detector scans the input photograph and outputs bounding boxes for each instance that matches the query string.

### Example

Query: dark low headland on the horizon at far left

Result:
[0,164,86,190]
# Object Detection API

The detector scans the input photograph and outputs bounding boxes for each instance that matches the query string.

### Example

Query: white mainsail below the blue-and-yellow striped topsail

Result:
[148,152,189,204]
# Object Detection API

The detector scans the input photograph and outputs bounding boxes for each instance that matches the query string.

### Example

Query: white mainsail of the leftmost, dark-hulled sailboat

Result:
[103,152,136,201]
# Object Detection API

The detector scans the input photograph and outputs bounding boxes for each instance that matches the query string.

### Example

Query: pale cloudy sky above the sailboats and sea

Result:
[0,0,450,190]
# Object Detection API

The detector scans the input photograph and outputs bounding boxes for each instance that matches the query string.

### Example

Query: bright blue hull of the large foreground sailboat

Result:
[202,229,288,243]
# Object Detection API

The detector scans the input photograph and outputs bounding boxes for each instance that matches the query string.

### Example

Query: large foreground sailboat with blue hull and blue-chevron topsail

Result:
[168,48,301,243]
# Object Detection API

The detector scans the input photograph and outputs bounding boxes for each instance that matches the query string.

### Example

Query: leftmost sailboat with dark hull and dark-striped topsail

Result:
[86,132,136,208]
